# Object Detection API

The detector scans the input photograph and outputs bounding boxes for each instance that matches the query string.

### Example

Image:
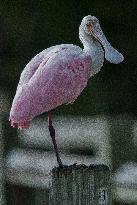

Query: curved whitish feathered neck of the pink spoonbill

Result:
[79,32,104,74]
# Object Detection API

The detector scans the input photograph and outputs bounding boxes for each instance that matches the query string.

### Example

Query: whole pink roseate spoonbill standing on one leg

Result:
[9,15,124,167]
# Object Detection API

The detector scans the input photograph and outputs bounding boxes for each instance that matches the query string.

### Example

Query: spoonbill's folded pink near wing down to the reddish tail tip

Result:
[10,47,91,128]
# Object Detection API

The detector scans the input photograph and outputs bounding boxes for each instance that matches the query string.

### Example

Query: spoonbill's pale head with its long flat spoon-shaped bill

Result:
[79,15,124,64]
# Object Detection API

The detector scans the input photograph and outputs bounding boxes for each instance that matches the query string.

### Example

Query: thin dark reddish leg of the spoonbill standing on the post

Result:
[48,111,63,168]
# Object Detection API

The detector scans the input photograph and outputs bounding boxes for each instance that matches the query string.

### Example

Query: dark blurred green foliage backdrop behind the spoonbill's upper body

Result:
[0,0,137,115]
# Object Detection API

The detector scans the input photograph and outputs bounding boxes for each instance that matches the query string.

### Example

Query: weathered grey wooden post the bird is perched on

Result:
[49,164,111,205]
